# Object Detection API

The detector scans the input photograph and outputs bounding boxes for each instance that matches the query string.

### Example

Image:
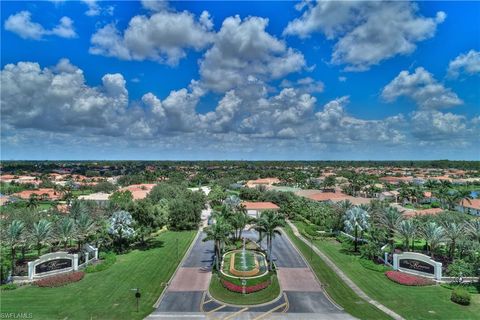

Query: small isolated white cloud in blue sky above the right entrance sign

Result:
[382,67,463,109]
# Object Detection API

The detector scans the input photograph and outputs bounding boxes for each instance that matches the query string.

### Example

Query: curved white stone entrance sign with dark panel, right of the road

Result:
[393,252,442,280]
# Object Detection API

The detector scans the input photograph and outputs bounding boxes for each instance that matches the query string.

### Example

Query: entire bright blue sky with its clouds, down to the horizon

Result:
[1,1,480,160]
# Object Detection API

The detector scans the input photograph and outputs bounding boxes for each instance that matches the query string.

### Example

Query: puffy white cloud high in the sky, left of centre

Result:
[90,11,213,65]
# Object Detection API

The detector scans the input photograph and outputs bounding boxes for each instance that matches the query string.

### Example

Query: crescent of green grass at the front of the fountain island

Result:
[209,274,280,305]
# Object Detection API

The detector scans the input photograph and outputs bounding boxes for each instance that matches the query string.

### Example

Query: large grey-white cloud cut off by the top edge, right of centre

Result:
[284,1,446,71]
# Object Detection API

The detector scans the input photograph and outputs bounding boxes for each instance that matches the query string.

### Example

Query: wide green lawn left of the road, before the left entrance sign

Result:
[0,231,195,320]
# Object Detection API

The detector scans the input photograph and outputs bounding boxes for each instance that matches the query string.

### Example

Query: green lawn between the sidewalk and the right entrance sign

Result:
[298,225,480,319]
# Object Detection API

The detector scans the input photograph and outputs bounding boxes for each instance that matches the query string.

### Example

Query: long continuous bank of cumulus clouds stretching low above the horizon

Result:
[0,59,480,158]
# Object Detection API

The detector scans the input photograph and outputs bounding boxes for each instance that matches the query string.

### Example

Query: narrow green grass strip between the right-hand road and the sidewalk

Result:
[285,226,390,319]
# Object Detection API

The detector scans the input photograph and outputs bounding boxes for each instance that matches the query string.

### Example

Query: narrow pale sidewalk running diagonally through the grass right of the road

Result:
[287,220,405,320]
